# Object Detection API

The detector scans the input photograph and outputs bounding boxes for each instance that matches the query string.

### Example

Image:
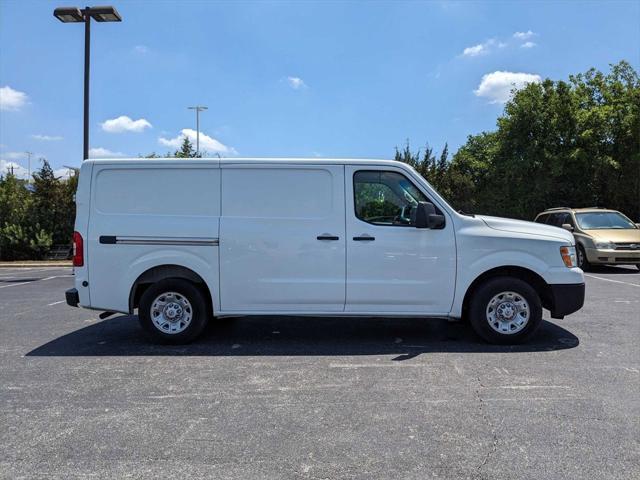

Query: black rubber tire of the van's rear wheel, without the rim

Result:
[138,278,210,345]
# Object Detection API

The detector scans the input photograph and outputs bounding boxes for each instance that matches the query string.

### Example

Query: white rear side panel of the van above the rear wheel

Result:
[86,165,220,312]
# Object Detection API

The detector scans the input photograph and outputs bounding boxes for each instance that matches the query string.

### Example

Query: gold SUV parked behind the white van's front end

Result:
[535,207,640,270]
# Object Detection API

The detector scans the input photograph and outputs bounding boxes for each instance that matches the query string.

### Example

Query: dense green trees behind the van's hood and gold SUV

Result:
[395,61,640,222]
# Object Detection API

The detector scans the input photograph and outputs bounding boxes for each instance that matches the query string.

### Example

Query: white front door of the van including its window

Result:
[345,166,456,315]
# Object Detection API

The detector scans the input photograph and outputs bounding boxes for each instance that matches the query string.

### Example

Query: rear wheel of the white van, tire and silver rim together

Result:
[138,278,208,344]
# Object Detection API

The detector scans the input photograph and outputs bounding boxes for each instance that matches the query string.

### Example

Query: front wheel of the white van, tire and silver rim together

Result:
[469,277,542,344]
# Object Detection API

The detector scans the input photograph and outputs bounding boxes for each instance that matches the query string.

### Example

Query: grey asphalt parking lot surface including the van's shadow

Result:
[0,268,640,480]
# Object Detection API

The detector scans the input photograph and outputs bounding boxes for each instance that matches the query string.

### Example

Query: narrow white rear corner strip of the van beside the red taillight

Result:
[73,162,93,307]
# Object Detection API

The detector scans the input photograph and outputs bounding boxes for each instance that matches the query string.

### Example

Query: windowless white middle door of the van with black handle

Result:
[219,163,346,313]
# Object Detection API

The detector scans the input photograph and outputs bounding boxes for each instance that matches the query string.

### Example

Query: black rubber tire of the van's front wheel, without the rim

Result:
[469,277,542,345]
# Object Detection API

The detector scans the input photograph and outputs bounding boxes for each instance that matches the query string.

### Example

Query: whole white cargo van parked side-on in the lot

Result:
[66,158,584,343]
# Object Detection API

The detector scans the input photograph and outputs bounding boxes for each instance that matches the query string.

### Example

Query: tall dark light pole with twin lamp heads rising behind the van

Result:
[53,7,122,160]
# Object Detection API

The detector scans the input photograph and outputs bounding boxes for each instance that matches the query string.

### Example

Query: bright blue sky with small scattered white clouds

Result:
[0,0,640,176]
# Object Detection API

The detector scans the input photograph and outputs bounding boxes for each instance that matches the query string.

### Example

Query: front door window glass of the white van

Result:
[353,170,428,226]
